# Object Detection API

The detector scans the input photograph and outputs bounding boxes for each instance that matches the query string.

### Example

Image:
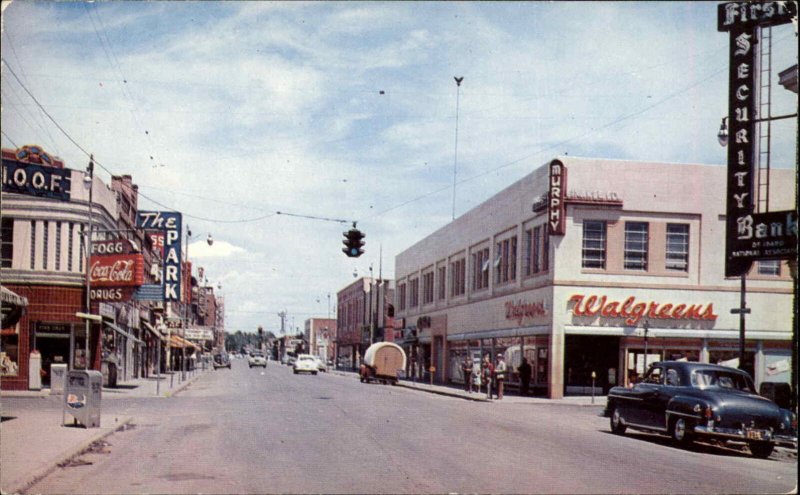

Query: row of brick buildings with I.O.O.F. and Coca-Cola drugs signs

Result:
[0,146,212,390]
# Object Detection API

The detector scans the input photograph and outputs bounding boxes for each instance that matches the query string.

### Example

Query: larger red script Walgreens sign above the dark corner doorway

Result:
[569,294,719,326]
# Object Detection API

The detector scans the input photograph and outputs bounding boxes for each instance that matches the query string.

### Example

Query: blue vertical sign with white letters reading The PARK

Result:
[136,211,183,302]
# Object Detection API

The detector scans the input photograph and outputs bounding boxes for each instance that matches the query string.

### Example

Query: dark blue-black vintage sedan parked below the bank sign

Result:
[605,361,797,458]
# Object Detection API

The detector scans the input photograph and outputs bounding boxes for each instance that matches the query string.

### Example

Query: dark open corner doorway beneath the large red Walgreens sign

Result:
[564,335,620,395]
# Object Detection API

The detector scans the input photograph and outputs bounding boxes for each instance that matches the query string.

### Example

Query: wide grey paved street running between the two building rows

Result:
[21,360,797,493]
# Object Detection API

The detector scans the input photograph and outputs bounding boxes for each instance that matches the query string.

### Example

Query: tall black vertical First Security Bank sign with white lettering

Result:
[717,2,797,277]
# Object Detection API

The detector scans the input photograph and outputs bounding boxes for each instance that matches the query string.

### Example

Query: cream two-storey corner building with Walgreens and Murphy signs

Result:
[395,157,796,398]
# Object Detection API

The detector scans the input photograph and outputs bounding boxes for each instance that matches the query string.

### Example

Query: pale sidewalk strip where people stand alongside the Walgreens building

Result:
[331,370,606,408]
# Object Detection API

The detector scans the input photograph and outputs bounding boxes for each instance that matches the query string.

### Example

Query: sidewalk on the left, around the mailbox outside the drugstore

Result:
[0,370,204,494]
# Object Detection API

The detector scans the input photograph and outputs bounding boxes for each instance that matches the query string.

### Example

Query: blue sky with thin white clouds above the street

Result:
[0,1,797,334]
